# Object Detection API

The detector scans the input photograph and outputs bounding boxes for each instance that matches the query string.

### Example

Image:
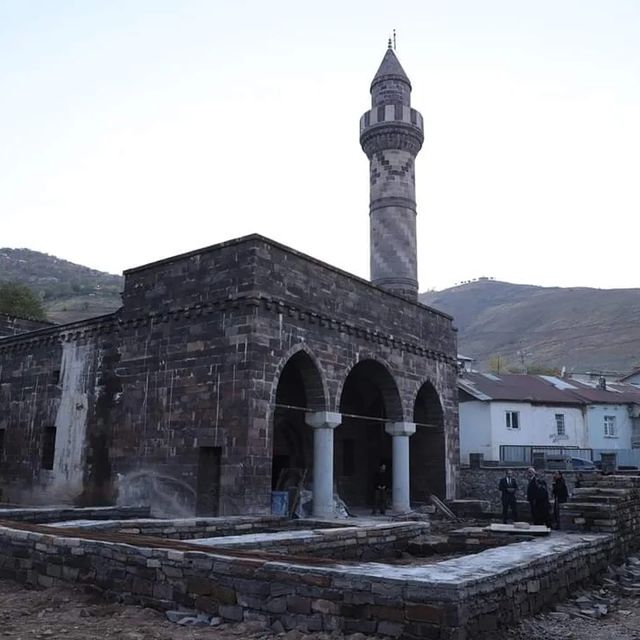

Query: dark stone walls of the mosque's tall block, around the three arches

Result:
[114,236,458,515]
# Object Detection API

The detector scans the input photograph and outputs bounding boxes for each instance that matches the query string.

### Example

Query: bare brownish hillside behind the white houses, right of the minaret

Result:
[420,280,640,372]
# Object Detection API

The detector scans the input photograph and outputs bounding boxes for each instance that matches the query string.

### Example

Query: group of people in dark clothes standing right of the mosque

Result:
[498,467,569,528]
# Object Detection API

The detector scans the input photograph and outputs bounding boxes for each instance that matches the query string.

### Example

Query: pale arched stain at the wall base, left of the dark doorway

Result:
[116,469,196,518]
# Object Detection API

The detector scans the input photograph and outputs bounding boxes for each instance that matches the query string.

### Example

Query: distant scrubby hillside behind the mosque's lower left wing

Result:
[0,248,124,323]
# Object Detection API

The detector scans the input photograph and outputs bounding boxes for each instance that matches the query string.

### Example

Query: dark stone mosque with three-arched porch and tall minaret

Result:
[0,48,459,517]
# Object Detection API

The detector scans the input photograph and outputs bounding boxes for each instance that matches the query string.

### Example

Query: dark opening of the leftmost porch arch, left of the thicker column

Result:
[271,347,326,489]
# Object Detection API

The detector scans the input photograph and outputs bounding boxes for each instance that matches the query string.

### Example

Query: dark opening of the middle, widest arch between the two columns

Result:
[334,357,403,507]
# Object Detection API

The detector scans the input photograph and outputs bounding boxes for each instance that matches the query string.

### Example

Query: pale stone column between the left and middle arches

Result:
[305,411,342,518]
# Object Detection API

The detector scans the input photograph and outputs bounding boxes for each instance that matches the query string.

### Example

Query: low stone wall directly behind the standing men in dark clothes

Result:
[459,467,584,520]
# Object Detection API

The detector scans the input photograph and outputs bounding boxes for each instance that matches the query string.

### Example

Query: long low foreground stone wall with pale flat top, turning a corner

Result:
[0,476,640,640]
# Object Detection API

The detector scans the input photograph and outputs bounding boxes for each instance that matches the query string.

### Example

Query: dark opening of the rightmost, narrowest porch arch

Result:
[409,380,446,503]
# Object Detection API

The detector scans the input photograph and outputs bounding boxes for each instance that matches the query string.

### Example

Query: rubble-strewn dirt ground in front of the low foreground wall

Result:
[0,580,640,640]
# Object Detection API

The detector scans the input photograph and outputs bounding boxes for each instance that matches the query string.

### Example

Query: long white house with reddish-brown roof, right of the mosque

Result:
[458,372,640,463]
